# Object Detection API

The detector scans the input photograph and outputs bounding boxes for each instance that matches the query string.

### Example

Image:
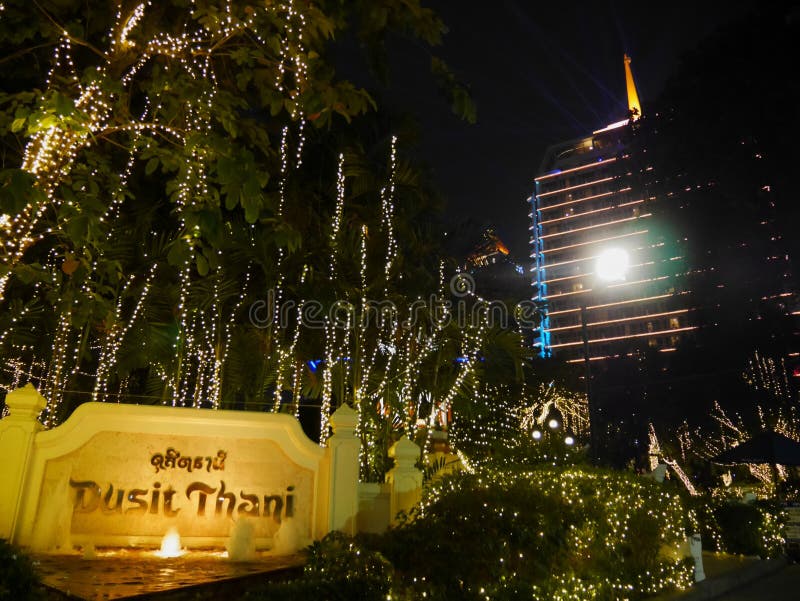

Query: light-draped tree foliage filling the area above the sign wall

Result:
[0,0,521,480]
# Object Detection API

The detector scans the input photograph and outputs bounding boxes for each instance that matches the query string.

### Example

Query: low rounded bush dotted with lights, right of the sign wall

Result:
[250,467,692,601]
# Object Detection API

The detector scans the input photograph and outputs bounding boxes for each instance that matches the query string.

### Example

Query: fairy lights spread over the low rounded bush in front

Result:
[418,466,697,601]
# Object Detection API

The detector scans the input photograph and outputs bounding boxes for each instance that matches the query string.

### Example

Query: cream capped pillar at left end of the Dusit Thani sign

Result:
[0,384,47,542]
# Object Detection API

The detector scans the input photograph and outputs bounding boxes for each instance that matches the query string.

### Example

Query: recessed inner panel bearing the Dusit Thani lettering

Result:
[37,432,316,547]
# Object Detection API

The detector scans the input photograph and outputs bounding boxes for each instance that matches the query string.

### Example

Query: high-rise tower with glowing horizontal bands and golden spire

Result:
[529,56,694,361]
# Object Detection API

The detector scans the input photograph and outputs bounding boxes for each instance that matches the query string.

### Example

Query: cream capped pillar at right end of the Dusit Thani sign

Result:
[326,405,361,534]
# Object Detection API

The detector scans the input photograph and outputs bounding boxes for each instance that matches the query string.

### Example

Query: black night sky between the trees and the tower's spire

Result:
[382,0,752,258]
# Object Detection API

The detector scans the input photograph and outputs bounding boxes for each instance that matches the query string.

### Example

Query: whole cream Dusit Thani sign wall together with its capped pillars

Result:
[0,385,422,553]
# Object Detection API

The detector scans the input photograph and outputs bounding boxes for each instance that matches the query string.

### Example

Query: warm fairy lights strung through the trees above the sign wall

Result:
[0,0,520,494]
